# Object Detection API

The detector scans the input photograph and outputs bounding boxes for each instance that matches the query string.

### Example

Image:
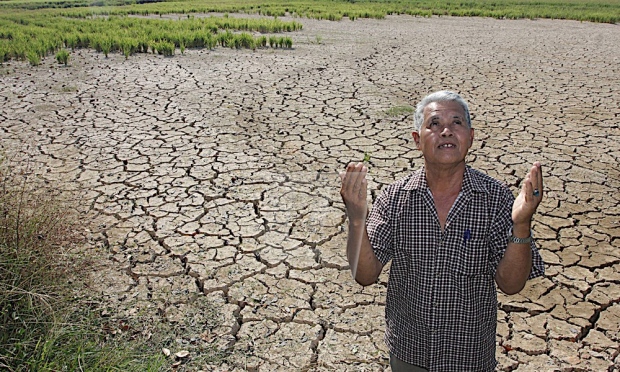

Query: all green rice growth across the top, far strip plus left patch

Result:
[0,0,620,65]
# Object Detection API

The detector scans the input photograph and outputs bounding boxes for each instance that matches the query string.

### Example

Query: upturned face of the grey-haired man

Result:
[413,101,474,165]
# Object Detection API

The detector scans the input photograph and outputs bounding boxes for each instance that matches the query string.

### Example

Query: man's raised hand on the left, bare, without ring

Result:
[340,163,368,223]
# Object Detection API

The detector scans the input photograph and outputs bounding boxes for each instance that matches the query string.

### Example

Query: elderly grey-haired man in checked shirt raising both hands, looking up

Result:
[340,91,544,372]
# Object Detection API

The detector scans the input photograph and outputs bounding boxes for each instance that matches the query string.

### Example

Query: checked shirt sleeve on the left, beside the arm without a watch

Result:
[366,188,394,266]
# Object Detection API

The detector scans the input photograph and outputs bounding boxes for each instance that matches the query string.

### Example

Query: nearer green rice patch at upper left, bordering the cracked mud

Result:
[0,12,302,65]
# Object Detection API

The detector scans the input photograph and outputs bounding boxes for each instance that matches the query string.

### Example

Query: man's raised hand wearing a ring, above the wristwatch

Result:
[512,162,543,225]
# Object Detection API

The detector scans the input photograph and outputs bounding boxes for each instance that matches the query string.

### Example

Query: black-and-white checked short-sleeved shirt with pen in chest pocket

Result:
[367,167,544,372]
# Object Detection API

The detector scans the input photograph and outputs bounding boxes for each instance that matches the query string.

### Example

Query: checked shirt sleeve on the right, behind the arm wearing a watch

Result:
[489,188,545,279]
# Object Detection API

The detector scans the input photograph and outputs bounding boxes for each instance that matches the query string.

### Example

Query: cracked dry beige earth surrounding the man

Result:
[0,16,620,371]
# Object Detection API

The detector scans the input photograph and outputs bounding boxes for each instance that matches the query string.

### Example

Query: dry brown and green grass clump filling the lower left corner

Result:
[0,157,164,371]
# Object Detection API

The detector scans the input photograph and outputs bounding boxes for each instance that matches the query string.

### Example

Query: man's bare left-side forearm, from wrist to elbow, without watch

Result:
[347,220,383,286]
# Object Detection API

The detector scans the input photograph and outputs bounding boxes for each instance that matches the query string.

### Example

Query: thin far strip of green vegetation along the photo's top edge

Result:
[0,0,620,23]
